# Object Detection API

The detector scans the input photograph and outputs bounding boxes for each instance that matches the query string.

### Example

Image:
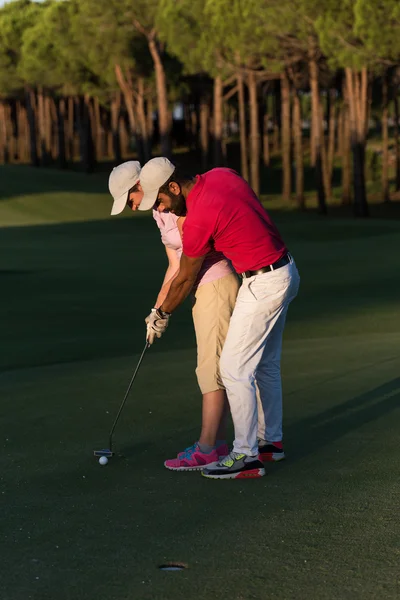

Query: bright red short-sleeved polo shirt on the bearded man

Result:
[183,168,287,273]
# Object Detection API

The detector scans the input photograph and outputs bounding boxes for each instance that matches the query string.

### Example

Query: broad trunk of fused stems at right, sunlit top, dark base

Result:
[345,67,369,217]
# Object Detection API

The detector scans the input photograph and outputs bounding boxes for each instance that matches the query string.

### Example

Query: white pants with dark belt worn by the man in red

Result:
[220,259,300,456]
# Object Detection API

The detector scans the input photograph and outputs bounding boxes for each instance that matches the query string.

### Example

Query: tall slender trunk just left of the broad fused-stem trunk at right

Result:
[308,40,327,215]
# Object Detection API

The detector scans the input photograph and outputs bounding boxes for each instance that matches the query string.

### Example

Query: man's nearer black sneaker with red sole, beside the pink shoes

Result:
[201,452,265,479]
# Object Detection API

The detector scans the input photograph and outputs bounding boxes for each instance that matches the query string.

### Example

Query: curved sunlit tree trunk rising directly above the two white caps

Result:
[149,38,172,158]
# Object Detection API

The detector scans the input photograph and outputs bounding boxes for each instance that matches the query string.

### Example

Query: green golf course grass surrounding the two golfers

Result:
[0,167,400,600]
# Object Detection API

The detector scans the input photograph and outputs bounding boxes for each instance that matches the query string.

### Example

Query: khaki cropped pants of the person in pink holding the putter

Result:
[192,273,240,394]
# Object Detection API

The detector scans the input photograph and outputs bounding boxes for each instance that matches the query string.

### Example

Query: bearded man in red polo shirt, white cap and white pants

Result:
[139,158,300,479]
